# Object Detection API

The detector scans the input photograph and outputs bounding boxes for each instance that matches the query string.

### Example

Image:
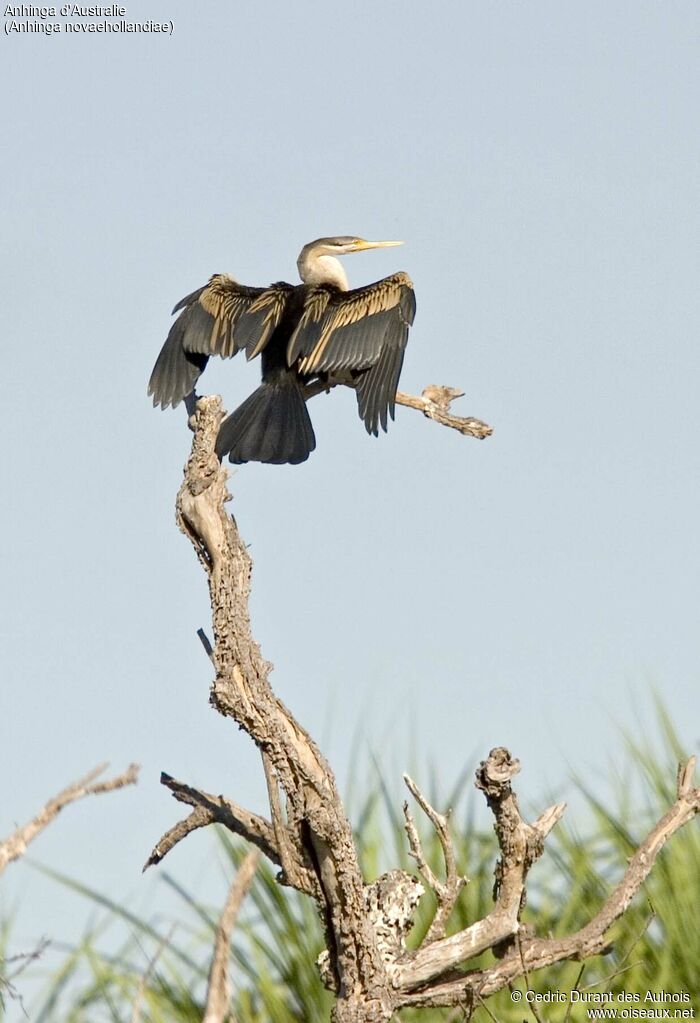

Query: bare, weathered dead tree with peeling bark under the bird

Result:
[146,388,700,1023]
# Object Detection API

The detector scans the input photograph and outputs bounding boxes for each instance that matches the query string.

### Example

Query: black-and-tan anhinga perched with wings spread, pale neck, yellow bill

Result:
[148,235,415,464]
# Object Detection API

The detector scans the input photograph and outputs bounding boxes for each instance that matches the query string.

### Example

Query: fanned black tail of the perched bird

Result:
[216,374,316,465]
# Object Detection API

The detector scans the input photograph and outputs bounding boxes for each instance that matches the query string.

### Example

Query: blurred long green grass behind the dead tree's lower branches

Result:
[0,707,700,1023]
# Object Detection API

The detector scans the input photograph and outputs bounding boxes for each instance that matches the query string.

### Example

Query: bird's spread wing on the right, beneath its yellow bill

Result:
[287,273,415,434]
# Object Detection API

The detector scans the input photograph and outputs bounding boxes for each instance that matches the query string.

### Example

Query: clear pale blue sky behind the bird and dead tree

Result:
[0,0,700,1014]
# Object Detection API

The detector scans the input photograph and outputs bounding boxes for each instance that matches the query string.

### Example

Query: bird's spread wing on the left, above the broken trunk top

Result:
[148,273,293,408]
